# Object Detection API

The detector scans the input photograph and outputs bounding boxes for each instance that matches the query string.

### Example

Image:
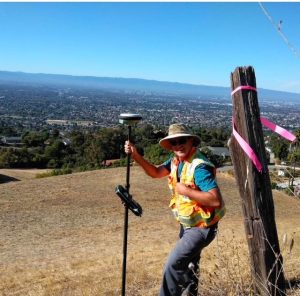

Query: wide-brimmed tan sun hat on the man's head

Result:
[159,123,200,150]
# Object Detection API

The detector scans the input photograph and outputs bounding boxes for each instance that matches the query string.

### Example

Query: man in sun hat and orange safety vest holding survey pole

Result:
[125,123,225,296]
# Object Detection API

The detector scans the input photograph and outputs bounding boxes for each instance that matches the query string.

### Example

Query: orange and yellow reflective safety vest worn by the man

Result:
[168,151,226,227]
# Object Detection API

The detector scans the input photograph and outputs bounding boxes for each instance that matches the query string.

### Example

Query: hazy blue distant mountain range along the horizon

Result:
[0,71,300,103]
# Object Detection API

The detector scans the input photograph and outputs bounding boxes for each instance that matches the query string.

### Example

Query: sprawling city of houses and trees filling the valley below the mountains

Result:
[0,85,300,135]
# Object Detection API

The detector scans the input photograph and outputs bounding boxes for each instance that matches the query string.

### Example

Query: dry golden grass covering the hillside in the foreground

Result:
[0,167,300,296]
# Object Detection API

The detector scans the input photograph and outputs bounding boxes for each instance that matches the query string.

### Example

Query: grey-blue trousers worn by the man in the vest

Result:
[159,226,217,296]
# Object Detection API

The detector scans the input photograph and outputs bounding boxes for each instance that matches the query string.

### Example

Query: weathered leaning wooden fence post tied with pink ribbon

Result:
[229,67,285,296]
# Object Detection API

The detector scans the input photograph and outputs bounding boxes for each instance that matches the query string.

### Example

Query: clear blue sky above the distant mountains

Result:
[0,2,300,93]
